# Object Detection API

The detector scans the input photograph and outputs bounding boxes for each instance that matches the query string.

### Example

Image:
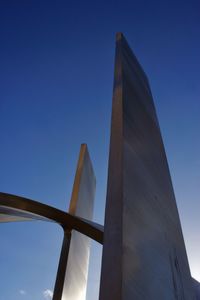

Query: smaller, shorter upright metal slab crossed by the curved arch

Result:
[53,144,96,300]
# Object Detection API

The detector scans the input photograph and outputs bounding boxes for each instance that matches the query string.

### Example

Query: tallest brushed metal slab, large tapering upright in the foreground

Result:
[99,33,195,300]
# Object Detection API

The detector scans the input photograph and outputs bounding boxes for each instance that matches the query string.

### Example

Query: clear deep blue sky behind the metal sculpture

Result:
[0,0,200,300]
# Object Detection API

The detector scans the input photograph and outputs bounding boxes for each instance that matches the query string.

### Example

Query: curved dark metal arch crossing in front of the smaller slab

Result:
[0,192,103,244]
